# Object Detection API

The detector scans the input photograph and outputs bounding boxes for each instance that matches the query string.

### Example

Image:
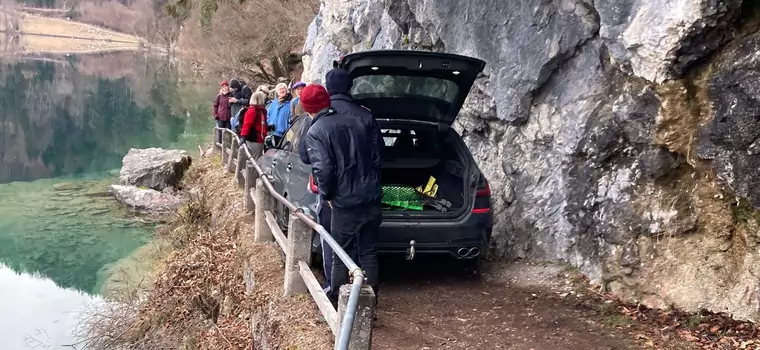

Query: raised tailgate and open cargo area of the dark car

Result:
[334,50,485,220]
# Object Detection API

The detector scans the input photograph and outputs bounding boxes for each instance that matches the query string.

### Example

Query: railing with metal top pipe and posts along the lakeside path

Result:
[212,127,375,350]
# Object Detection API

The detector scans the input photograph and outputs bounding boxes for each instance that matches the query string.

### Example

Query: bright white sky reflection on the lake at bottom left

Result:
[0,264,102,350]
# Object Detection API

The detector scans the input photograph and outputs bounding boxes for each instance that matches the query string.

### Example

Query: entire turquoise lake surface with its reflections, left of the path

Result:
[0,53,216,350]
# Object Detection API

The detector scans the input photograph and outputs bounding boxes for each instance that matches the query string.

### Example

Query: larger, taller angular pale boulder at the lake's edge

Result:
[119,148,192,191]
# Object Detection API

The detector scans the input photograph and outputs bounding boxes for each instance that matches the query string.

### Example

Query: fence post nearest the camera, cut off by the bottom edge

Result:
[338,284,376,350]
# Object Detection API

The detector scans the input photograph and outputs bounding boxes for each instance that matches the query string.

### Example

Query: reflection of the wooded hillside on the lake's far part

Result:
[0,52,202,183]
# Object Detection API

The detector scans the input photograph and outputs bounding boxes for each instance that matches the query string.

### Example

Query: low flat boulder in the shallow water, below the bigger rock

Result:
[109,185,182,214]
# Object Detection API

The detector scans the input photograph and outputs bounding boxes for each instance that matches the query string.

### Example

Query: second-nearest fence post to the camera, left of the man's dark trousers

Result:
[284,214,311,297]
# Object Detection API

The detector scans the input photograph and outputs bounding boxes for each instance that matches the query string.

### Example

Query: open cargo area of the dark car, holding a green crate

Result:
[382,124,471,218]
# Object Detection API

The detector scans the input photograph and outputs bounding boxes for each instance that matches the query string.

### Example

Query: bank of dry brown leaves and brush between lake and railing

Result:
[79,155,332,349]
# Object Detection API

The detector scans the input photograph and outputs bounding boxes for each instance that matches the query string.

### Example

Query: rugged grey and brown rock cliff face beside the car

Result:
[304,0,760,320]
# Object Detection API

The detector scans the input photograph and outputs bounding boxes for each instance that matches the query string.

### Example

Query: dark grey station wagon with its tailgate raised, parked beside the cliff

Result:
[258,50,493,263]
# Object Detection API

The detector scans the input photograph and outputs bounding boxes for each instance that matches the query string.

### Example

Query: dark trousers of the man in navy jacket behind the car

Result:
[328,202,383,308]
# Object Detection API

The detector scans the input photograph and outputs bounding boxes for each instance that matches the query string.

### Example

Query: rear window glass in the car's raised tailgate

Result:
[351,75,459,103]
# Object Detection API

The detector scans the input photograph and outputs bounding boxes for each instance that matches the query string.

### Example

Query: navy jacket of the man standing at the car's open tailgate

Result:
[300,105,383,209]
